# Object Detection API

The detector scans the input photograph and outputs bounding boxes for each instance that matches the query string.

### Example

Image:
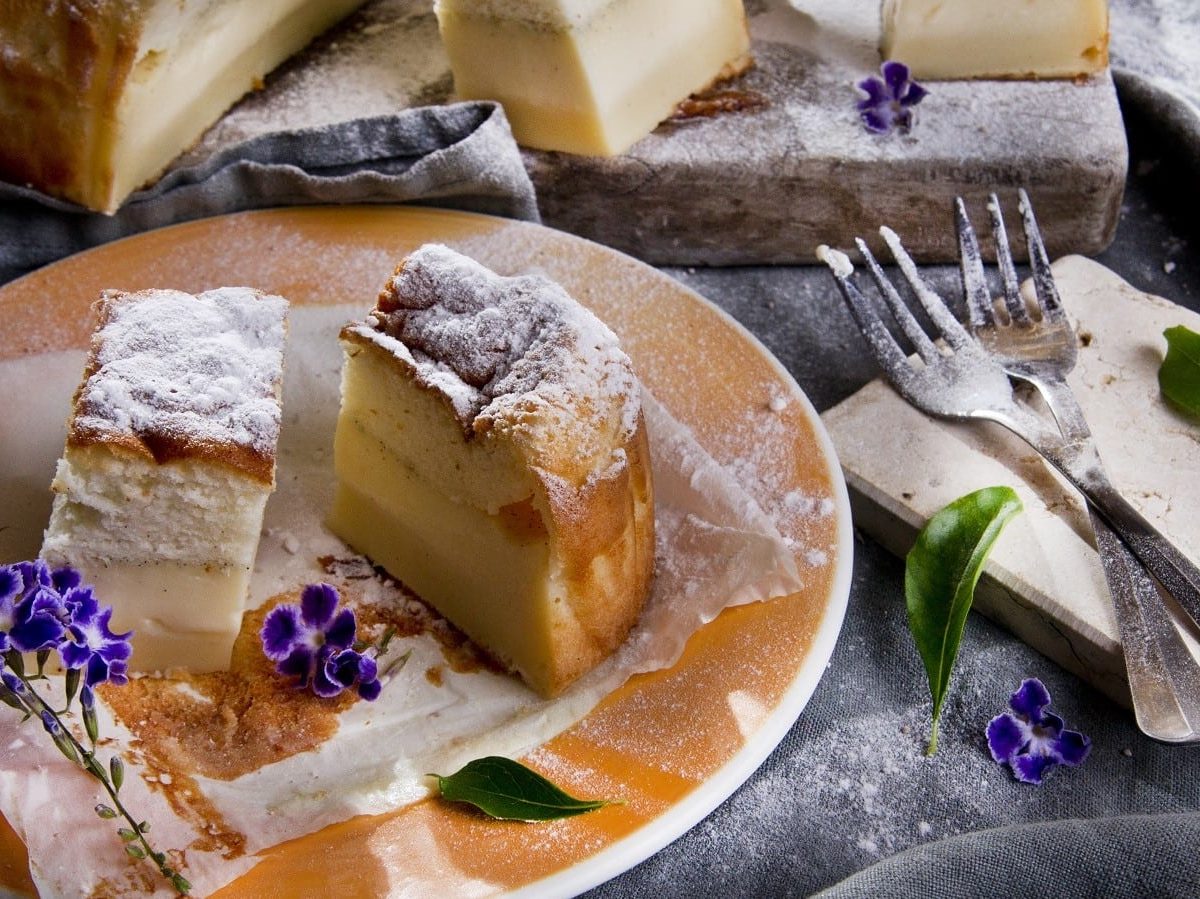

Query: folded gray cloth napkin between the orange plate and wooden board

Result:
[0,103,538,283]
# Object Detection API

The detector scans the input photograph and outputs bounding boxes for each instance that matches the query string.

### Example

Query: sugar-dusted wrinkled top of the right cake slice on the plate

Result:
[356,244,638,456]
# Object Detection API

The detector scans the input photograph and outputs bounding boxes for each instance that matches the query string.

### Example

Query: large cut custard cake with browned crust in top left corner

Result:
[0,0,364,212]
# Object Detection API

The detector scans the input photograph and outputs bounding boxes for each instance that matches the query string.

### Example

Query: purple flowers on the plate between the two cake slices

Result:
[259,583,382,700]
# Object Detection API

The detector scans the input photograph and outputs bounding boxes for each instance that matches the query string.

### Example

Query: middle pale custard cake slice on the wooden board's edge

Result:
[434,0,750,156]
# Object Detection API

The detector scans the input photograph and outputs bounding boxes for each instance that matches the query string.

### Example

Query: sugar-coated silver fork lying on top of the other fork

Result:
[817,212,1200,741]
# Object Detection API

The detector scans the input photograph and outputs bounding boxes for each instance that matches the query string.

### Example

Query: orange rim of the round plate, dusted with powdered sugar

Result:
[0,208,848,899]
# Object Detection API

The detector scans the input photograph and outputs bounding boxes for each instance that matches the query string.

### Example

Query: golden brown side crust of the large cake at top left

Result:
[0,0,143,211]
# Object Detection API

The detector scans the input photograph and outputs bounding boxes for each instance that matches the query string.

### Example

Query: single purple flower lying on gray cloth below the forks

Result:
[988,677,1092,784]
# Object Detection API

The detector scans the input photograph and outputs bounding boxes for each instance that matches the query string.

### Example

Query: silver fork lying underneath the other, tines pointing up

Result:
[954,190,1200,743]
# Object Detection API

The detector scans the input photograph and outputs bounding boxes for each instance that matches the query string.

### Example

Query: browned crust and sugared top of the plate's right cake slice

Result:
[341,246,654,696]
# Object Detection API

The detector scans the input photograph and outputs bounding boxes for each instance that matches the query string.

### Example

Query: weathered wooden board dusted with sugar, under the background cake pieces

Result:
[184,0,1128,265]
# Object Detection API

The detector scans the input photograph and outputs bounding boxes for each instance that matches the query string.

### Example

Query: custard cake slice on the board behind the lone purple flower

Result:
[882,0,1109,79]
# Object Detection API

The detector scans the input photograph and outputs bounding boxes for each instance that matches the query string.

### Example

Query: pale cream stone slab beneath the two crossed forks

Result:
[822,257,1200,705]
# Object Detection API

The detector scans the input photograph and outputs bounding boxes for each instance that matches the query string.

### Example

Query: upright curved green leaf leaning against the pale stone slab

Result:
[904,487,1021,755]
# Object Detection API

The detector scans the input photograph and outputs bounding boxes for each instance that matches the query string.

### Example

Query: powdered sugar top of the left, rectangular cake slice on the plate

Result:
[73,287,287,459]
